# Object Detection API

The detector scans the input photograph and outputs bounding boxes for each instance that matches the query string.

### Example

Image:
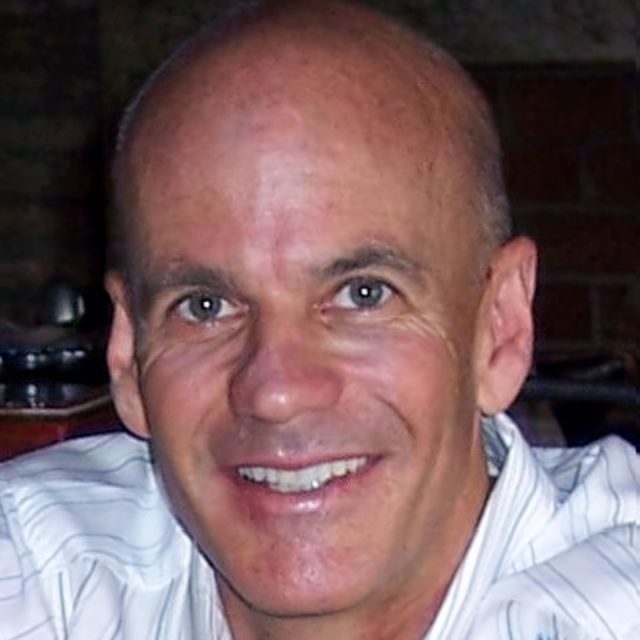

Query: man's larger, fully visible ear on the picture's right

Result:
[475,237,537,415]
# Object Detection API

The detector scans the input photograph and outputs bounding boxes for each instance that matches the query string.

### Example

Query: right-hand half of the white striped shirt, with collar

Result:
[427,416,640,640]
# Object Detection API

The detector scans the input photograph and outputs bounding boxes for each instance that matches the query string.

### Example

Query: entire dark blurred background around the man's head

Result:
[0,0,640,452]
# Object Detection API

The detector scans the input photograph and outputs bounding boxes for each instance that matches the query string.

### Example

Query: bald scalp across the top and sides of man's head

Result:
[115,1,510,286]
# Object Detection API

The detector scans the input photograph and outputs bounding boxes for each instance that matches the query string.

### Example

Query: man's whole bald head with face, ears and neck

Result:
[107,5,535,640]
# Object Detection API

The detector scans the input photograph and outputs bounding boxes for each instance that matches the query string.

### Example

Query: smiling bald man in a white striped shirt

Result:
[0,2,640,640]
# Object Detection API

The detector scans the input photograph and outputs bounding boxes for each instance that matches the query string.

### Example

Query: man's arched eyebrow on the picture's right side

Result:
[318,243,429,280]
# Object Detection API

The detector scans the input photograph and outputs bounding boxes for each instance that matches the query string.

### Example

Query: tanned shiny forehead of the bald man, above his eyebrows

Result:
[127,35,476,278]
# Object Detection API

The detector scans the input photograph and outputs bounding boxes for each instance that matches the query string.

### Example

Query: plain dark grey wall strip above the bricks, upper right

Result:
[371,0,639,64]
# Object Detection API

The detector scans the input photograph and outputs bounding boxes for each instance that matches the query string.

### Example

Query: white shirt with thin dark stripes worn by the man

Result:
[0,416,640,640]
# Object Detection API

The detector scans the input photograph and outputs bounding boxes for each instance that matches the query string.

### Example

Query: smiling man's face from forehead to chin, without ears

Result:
[115,55,486,615]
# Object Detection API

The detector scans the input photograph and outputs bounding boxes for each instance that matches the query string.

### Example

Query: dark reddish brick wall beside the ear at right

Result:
[472,65,640,352]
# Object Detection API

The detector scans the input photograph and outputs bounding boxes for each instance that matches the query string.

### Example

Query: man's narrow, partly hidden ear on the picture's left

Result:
[105,273,149,438]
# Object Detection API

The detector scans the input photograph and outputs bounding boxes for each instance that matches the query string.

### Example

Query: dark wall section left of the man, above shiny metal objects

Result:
[0,0,104,324]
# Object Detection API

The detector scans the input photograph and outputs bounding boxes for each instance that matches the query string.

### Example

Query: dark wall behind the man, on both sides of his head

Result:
[0,0,640,358]
